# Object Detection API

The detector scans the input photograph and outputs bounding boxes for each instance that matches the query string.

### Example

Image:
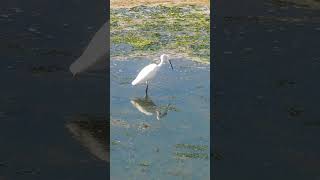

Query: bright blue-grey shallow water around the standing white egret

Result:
[110,59,210,179]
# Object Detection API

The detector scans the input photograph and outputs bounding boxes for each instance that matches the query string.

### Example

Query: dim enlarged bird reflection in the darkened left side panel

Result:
[66,116,109,162]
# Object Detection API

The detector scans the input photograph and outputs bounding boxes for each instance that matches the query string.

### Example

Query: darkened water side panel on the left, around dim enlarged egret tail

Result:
[0,0,109,180]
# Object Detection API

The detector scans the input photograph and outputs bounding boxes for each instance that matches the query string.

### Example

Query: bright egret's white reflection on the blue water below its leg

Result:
[130,96,170,120]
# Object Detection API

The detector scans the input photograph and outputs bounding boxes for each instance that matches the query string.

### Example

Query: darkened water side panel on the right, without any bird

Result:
[211,0,320,180]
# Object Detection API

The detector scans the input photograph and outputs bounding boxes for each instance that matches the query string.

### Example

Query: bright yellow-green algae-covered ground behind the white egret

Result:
[110,5,210,63]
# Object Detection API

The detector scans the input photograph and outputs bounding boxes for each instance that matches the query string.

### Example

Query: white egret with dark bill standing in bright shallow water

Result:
[131,54,173,95]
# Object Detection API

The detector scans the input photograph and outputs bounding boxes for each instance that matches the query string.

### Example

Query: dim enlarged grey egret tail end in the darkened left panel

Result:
[70,22,109,75]
